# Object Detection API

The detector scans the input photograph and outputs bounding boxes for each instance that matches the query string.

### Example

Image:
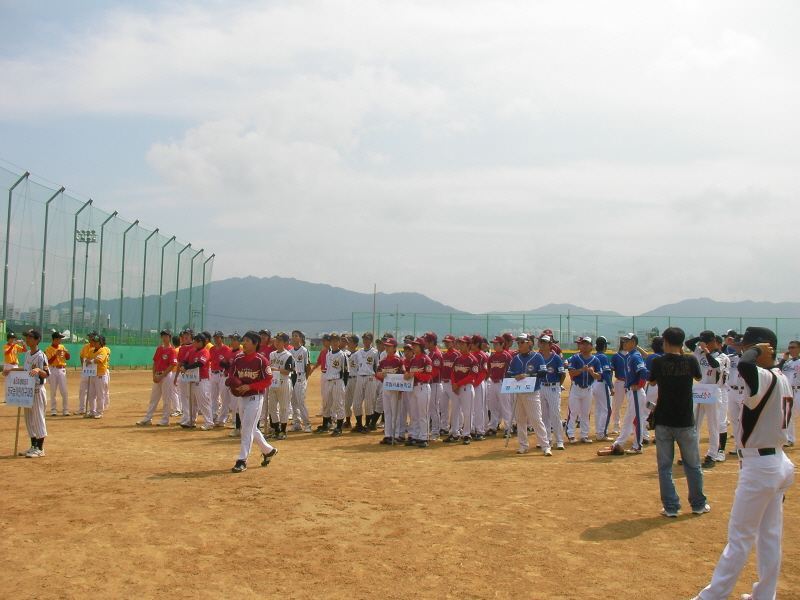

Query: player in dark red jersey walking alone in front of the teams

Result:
[225,331,278,473]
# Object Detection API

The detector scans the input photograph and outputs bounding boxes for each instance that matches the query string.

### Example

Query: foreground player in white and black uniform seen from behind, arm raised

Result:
[695,327,794,600]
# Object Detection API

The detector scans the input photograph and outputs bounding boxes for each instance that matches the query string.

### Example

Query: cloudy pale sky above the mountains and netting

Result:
[0,0,800,314]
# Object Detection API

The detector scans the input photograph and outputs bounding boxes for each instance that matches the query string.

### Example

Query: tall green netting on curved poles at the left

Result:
[0,167,214,346]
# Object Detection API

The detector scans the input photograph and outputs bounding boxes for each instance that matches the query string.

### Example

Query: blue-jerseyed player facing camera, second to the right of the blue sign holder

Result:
[567,336,603,444]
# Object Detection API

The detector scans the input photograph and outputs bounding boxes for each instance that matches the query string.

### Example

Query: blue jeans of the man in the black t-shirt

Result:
[656,425,706,512]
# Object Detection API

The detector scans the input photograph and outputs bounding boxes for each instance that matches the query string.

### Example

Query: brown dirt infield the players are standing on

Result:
[0,371,800,600]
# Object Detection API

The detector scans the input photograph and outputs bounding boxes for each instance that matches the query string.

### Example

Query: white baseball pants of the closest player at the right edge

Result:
[697,452,794,600]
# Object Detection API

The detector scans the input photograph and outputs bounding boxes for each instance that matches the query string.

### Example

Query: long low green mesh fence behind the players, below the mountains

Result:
[351,312,800,350]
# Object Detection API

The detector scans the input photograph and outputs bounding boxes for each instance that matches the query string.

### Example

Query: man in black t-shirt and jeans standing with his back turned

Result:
[649,327,711,517]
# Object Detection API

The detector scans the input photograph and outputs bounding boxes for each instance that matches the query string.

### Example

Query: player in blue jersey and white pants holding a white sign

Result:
[507,333,552,456]
